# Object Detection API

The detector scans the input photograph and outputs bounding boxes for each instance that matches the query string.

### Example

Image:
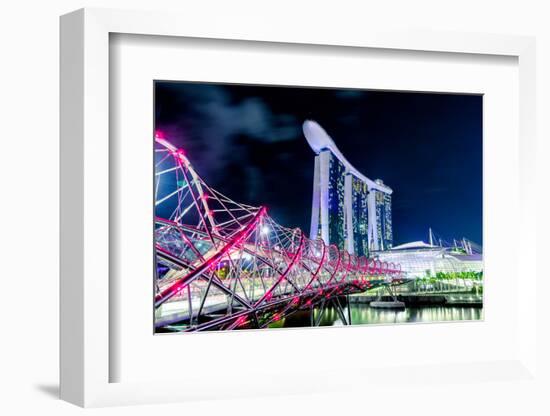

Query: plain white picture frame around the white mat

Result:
[60,9,540,407]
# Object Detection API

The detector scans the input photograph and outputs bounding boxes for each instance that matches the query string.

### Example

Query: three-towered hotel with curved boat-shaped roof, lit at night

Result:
[303,120,393,256]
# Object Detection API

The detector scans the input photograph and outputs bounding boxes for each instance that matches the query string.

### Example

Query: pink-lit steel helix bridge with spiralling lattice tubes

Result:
[154,136,403,331]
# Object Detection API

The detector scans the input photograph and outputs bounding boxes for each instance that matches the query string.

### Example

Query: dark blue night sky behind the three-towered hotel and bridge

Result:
[155,81,482,245]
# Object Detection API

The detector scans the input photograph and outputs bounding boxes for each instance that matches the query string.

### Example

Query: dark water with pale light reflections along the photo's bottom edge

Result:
[270,304,483,328]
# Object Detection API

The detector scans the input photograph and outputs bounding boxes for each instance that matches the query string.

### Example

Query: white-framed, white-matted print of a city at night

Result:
[61,9,538,413]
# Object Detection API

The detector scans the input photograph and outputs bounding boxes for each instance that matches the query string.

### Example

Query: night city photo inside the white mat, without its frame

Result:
[151,80,484,334]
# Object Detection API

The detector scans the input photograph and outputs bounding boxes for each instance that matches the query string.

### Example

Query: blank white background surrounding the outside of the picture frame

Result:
[0,0,550,415]
